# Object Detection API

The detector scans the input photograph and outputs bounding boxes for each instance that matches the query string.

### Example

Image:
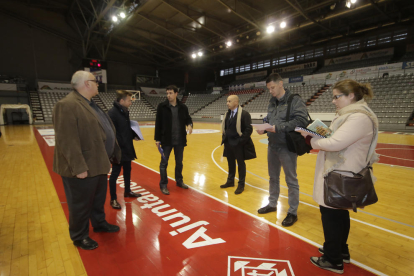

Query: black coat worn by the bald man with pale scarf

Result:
[221,109,256,160]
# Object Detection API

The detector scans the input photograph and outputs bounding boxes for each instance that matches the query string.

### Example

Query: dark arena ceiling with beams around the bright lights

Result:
[0,0,414,69]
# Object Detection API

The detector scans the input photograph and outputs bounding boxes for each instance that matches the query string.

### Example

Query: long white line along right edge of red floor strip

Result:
[132,160,387,276]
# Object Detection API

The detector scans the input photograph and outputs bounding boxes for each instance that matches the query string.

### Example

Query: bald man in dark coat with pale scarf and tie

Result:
[220,95,256,195]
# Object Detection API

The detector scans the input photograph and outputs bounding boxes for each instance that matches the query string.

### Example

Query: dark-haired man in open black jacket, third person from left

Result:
[154,85,193,195]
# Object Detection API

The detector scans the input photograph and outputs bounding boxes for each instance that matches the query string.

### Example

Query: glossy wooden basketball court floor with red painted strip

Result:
[0,122,414,276]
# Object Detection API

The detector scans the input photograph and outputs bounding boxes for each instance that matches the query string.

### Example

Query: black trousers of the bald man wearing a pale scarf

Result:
[224,143,246,186]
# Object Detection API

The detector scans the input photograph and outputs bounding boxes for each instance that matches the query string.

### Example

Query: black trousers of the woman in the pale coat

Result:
[319,206,351,264]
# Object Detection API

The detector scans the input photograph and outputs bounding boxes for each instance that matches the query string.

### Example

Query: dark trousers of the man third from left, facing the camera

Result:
[160,146,184,188]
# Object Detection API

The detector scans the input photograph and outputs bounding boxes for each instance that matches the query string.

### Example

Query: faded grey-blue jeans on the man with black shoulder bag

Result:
[267,146,299,215]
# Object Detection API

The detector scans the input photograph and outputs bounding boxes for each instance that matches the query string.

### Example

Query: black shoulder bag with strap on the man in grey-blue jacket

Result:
[286,94,312,156]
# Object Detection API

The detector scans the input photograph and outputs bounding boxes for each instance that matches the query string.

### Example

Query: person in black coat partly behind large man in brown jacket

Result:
[108,90,141,209]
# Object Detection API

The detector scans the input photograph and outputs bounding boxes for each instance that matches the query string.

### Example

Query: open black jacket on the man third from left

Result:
[154,99,193,146]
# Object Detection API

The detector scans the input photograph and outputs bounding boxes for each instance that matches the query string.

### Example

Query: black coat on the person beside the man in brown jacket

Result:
[108,102,137,162]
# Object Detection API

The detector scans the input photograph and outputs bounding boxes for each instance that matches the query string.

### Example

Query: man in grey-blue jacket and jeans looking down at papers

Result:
[257,73,308,227]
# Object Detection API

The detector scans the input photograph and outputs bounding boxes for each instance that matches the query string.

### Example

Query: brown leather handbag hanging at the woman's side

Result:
[324,164,378,213]
